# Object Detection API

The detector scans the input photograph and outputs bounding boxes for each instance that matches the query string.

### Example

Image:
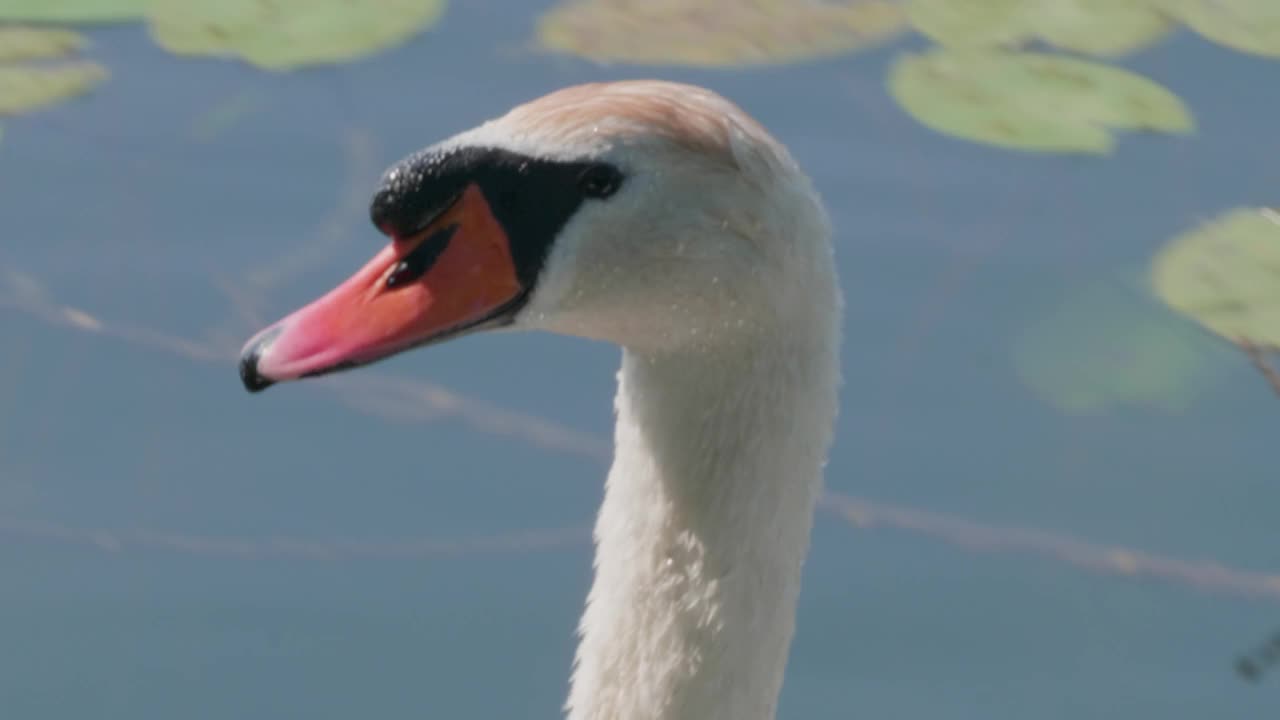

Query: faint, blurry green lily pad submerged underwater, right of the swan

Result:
[1014,274,1230,414]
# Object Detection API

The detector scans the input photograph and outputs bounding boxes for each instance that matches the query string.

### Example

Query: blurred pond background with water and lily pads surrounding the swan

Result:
[0,0,1280,720]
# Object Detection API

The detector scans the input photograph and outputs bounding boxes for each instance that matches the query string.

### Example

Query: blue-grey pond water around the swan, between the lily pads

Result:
[0,1,1280,720]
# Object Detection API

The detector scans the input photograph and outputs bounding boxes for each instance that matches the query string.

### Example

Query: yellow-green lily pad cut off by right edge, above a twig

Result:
[1151,208,1280,347]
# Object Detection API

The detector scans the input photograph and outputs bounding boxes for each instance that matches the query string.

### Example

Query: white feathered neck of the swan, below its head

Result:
[567,319,838,720]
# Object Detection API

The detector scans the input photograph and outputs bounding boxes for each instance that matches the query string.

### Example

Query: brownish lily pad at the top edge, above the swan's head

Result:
[538,0,906,68]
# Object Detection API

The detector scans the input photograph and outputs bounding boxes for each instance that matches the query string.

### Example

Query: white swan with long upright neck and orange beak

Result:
[239,81,842,720]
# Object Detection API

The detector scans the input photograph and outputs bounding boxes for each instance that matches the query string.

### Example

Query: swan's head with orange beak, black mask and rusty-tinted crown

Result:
[241,81,838,392]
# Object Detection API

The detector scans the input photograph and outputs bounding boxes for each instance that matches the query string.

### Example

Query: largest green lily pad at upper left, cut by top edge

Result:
[147,0,447,70]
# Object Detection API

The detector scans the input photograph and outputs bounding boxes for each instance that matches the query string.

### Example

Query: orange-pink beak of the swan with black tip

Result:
[239,184,527,392]
